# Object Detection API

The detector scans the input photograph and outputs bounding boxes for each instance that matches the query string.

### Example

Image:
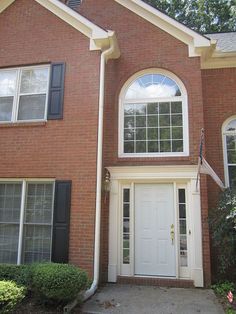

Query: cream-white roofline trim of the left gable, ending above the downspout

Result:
[0,0,120,50]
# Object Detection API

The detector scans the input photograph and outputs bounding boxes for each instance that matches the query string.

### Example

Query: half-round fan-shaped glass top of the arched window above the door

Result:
[125,74,181,100]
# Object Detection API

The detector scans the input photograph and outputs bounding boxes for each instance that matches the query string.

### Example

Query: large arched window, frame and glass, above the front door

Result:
[119,70,188,157]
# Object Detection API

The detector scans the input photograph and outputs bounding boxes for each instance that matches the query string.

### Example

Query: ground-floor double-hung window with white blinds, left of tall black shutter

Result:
[0,180,54,264]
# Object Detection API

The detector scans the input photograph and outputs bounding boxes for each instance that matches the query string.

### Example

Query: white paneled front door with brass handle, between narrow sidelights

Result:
[135,184,176,277]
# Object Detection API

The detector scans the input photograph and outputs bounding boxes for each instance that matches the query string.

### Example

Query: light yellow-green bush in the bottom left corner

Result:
[0,281,25,313]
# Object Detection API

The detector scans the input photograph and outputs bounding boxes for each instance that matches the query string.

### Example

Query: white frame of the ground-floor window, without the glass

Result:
[0,178,55,265]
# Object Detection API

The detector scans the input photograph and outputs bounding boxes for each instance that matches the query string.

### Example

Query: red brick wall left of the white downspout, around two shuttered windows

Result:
[0,0,100,274]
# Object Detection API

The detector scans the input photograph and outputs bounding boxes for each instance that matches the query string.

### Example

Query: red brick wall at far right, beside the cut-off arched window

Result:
[202,68,236,280]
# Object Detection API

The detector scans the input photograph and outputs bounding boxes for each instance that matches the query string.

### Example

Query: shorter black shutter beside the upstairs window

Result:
[48,63,65,120]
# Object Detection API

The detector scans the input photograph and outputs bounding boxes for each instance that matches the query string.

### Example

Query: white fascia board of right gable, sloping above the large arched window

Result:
[115,0,211,56]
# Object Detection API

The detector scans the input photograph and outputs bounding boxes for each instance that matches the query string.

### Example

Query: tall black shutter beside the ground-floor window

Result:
[52,181,71,263]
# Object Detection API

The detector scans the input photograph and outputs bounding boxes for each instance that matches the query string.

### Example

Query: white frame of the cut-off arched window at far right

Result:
[222,115,236,187]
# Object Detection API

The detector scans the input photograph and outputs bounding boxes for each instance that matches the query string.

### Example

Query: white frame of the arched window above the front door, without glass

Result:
[118,68,189,158]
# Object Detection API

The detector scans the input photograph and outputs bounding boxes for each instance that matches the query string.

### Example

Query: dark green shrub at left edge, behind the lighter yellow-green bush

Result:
[0,264,33,288]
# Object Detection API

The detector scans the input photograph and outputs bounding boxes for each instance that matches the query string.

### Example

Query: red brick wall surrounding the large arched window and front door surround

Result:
[79,0,210,284]
